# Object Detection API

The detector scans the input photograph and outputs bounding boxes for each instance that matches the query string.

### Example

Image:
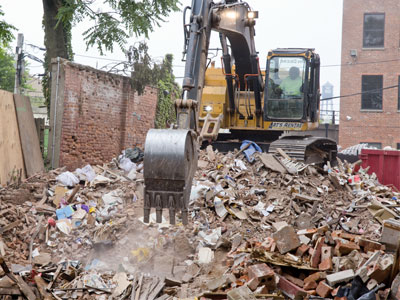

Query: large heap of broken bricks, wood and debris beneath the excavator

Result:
[0,144,400,300]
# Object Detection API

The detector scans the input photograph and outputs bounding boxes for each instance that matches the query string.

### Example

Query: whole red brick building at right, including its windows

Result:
[339,0,400,148]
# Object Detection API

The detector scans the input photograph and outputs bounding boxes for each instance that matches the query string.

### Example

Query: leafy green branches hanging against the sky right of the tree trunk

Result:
[57,0,179,54]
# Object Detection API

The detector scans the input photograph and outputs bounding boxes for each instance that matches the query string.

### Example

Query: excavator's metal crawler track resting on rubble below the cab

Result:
[268,135,337,164]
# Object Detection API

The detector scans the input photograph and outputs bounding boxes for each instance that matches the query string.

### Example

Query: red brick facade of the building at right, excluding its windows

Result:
[339,0,400,148]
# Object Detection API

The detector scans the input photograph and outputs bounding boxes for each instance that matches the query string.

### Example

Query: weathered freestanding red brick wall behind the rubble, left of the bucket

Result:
[53,61,158,169]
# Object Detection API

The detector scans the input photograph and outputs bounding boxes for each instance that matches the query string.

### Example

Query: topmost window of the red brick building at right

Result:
[363,14,385,48]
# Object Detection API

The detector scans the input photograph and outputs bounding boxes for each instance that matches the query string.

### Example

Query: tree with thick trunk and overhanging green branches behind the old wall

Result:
[42,0,179,107]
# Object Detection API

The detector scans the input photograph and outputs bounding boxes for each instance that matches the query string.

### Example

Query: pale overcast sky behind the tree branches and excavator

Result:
[0,0,343,105]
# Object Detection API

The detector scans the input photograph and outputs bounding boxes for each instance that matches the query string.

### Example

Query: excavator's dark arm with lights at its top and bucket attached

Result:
[144,0,262,224]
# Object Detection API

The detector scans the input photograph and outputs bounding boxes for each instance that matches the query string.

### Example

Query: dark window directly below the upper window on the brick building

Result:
[361,75,383,110]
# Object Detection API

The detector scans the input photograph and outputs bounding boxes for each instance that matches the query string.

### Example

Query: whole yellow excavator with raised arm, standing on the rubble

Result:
[144,0,337,224]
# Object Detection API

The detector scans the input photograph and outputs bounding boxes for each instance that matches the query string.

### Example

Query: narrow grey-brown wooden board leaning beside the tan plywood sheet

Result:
[14,94,44,177]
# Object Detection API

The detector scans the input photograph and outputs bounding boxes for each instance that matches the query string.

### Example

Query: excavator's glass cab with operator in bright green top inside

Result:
[264,48,320,123]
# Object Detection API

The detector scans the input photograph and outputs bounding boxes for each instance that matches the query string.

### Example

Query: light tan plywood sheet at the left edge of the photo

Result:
[0,90,25,185]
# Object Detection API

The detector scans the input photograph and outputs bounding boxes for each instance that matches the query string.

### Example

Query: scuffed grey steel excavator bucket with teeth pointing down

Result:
[144,129,198,224]
